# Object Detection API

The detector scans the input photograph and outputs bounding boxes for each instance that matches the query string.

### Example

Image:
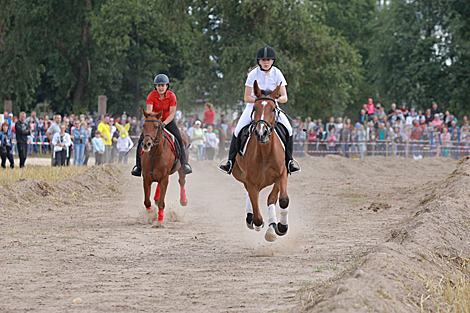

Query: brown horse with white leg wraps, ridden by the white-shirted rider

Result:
[232,81,289,241]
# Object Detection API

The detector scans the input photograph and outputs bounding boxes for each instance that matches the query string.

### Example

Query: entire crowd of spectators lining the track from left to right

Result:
[0,99,470,168]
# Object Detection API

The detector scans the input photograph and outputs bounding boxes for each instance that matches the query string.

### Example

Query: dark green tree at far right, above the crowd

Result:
[368,0,470,114]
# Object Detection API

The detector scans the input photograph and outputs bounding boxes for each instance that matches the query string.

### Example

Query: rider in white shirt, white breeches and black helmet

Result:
[219,46,300,174]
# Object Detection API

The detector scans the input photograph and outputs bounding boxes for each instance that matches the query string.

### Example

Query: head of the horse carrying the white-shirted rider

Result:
[253,80,281,143]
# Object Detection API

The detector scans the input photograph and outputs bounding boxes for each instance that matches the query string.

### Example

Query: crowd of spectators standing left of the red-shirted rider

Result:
[0,111,141,168]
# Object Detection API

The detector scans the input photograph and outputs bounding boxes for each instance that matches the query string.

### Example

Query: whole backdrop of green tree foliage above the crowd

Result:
[0,0,470,118]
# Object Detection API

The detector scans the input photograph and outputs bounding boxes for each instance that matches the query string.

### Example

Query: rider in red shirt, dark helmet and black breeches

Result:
[131,74,193,176]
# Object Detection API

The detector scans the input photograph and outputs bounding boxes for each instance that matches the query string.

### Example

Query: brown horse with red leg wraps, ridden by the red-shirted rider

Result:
[141,109,188,227]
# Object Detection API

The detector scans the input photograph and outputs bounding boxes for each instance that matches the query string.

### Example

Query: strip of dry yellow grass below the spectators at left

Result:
[0,165,89,185]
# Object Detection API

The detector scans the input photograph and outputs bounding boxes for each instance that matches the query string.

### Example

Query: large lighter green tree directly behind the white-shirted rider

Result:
[182,0,361,119]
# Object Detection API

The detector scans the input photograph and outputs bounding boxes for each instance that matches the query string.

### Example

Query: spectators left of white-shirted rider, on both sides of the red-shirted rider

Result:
[0,103,228,168]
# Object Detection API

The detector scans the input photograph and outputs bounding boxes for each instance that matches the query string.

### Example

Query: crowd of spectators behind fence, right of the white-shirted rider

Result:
[293,99,470,158]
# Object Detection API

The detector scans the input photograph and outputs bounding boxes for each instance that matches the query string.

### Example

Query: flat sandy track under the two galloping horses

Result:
[0,156,457,312]
